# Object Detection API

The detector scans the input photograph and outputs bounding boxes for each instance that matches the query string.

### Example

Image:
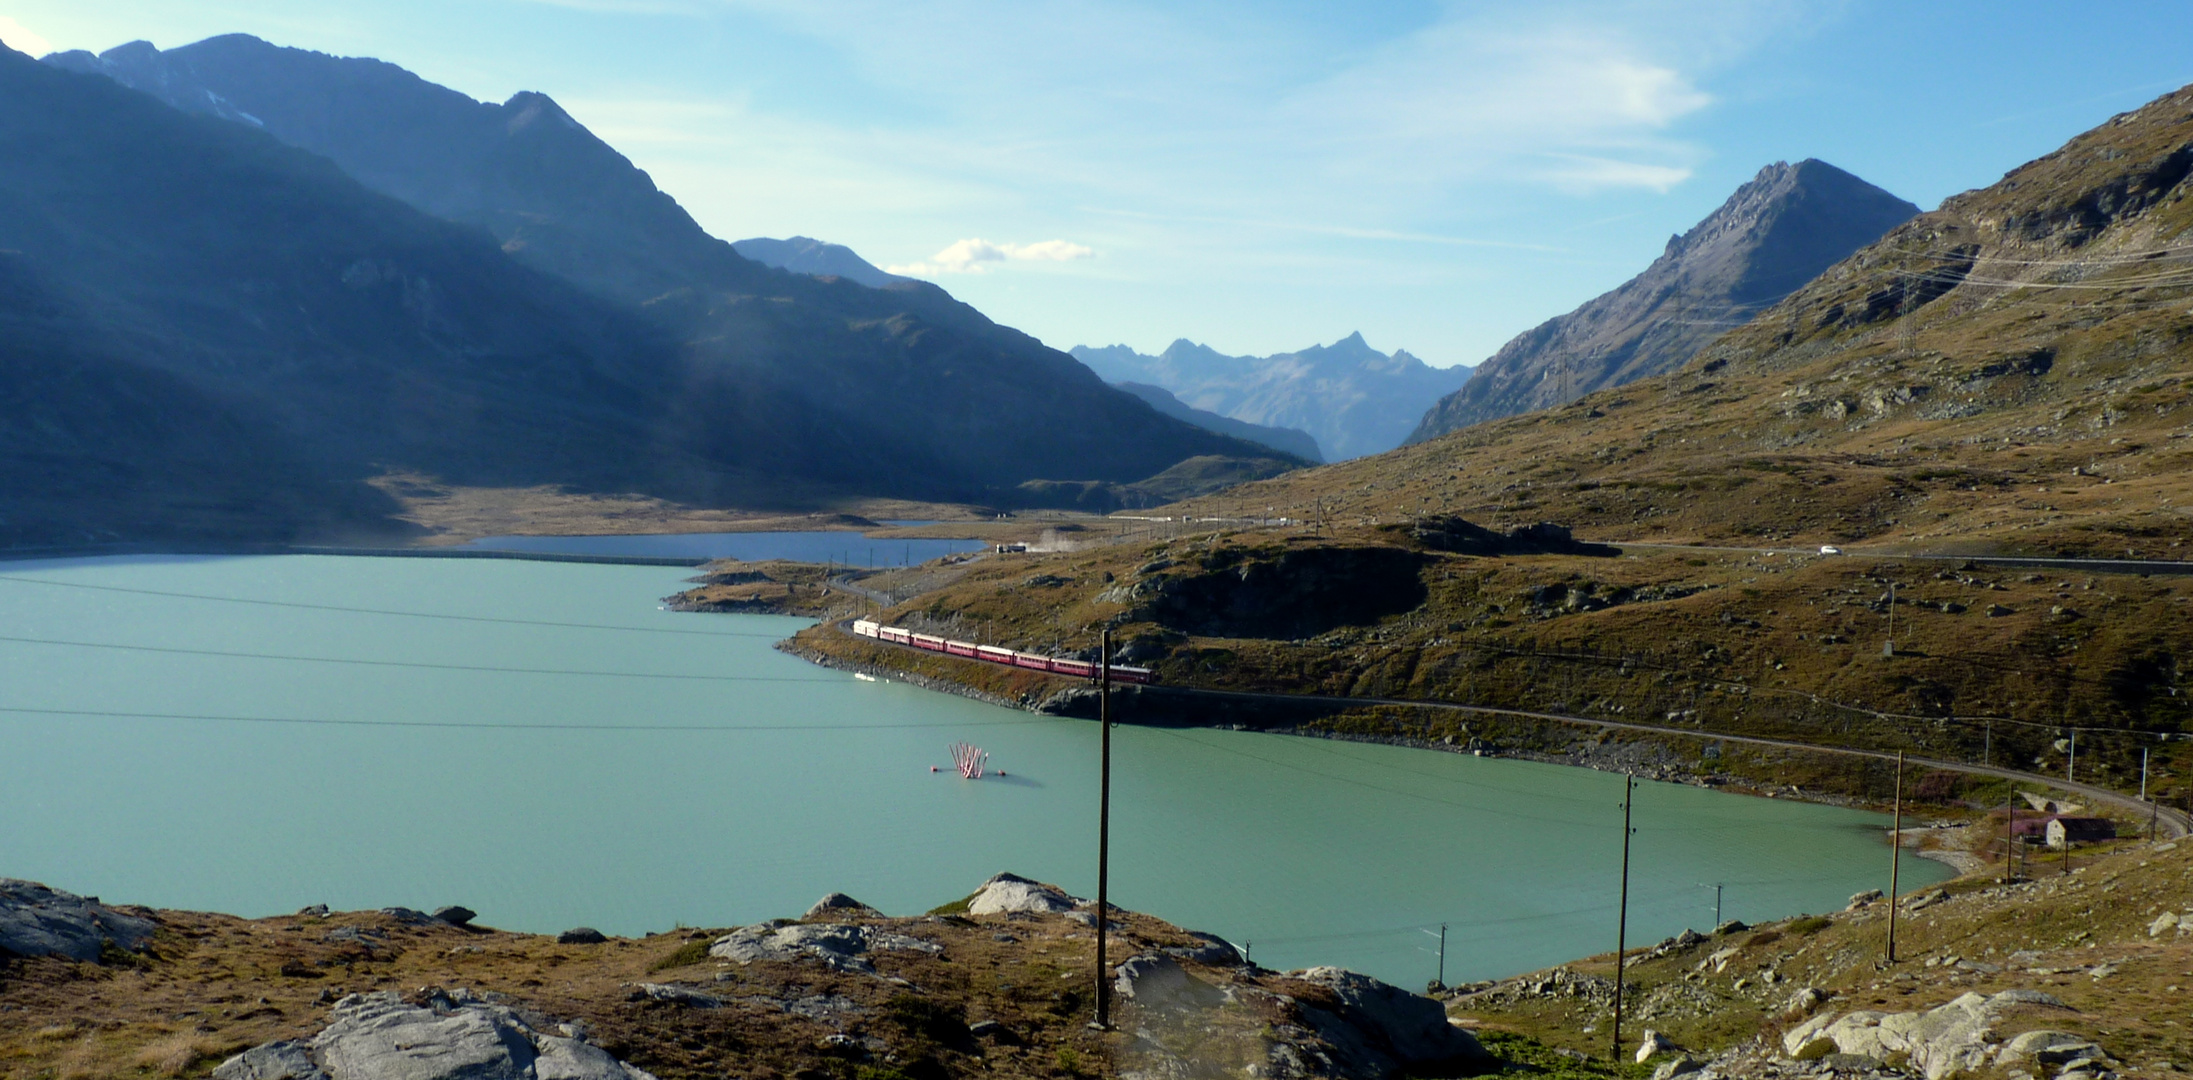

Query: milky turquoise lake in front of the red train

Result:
[0,555,1950,986]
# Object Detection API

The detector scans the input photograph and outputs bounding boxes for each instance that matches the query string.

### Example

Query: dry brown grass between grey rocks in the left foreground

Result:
[0,891,1456,1080]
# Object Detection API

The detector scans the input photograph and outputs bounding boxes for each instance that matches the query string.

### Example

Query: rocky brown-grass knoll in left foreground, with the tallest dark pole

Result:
[0,874,1498,1080]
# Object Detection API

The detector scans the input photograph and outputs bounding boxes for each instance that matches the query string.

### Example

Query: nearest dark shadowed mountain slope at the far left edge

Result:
[0,48,710,542]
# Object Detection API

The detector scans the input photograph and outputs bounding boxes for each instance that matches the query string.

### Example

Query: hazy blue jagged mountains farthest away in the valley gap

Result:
[1070,334,1472,461]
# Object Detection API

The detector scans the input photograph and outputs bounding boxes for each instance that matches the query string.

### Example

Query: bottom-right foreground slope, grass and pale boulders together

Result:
[1443,825,2193,1080]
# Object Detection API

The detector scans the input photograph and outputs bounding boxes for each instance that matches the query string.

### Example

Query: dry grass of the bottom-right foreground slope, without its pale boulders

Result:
[1452,836,2193,1076]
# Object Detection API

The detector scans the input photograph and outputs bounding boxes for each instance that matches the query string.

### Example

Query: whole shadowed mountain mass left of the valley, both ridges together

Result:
[17,35,1274,538]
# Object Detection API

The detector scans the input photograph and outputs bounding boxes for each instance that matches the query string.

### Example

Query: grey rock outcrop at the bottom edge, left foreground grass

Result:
[213,990,654,1080]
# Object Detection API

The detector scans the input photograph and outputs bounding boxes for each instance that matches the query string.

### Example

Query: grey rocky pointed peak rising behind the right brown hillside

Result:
[1408,158,1919,441]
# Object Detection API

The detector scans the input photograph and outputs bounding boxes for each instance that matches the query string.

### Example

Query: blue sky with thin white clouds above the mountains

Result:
[0,0,2193,364]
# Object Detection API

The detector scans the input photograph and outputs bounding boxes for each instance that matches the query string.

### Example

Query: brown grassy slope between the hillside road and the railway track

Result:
[780,529,2193,803]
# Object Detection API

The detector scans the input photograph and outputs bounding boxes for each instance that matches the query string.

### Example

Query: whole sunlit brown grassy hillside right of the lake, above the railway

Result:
[776,84,2193,801]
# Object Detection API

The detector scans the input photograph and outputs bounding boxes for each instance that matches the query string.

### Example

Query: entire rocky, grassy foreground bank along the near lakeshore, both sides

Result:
[0,820,2193,1080]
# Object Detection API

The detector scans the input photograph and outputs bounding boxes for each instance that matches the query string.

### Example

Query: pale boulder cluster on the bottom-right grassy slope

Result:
[1783,990,2064,1080]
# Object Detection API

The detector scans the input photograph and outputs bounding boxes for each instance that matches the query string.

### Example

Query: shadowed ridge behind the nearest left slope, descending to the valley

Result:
[48,35,1263,503]
